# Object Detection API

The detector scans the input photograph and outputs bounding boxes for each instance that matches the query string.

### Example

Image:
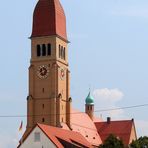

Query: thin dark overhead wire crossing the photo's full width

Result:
[0,103,148,118]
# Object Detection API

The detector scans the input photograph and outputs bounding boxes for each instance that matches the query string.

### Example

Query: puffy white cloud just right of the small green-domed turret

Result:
[93,88,124,119]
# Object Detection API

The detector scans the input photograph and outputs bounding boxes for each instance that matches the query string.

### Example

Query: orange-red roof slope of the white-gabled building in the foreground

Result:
[37,124,91,148]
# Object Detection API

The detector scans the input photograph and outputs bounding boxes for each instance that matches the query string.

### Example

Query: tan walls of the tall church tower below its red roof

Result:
[27,36,71,129]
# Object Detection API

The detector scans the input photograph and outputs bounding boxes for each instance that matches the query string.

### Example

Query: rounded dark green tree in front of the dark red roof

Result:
[99,134,124,148]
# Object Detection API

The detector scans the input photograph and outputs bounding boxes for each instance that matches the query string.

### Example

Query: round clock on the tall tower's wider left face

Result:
[37,65,49,79]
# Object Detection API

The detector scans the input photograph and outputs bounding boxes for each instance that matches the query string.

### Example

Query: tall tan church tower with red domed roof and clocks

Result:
[27,0,71,130]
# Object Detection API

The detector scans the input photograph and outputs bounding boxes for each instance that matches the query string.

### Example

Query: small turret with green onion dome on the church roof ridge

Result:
[85,92,94,120]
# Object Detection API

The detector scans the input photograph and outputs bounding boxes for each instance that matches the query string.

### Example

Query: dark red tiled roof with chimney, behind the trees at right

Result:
[95,120,133,145]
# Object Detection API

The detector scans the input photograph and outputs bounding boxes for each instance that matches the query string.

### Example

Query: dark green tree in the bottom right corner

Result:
[130,136,148,148]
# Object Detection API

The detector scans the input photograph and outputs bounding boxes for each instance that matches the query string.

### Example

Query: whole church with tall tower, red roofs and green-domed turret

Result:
[18,0,136,148]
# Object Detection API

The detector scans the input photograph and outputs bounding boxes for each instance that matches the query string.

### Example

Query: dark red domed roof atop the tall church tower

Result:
[31,0,67,40]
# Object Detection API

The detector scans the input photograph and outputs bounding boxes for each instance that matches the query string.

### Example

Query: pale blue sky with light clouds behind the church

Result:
[0,0,148,148]
